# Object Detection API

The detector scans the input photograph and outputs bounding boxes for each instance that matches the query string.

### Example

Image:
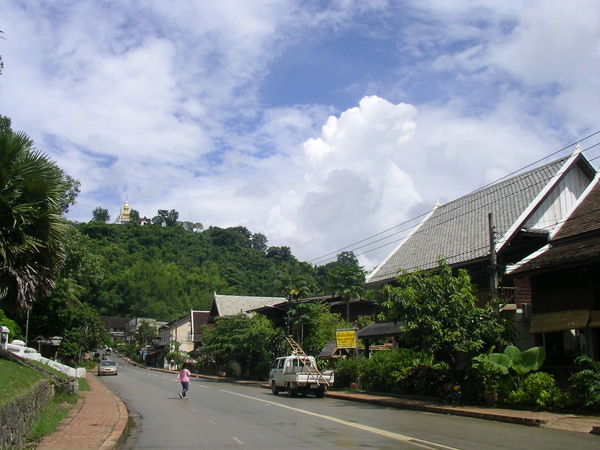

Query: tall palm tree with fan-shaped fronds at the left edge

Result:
[0,128,67,311]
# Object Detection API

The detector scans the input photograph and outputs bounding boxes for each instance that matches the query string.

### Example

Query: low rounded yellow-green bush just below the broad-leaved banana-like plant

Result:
[506,372,561,408]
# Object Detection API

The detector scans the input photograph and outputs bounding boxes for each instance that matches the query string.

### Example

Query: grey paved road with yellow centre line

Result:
[102,357,600,450]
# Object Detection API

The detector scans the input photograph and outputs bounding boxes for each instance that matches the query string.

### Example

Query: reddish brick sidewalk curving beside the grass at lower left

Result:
[37,372,128,450]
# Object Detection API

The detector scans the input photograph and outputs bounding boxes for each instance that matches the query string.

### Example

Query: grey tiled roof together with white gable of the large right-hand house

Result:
[366,149,596,299]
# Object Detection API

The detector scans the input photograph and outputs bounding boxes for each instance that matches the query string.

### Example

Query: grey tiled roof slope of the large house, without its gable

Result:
[367,156,569,284]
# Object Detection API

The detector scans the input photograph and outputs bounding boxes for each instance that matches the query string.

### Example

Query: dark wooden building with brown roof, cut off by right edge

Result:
[507,176,600,364]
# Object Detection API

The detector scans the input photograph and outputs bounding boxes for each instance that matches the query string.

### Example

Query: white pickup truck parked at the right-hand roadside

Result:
[269,355,334,398]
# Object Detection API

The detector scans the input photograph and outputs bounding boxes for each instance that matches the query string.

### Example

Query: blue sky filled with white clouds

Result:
[0,0,600,269]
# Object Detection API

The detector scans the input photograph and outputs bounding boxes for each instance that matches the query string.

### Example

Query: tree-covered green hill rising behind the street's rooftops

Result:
[71,221,332,320]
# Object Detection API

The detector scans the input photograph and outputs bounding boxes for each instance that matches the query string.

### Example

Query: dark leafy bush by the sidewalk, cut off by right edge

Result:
[568,356,600,412]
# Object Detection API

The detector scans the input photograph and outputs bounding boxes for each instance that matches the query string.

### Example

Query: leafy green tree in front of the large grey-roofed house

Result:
[382,261,511,364]
